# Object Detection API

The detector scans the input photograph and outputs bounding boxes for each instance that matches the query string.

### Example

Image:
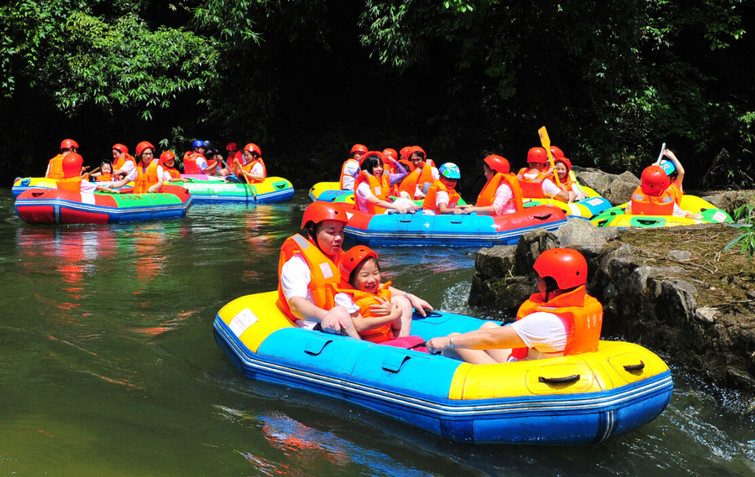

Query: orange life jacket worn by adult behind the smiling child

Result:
[277,234,341,321]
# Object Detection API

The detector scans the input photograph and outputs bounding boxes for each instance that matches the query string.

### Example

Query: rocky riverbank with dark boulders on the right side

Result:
[469,186,755,398]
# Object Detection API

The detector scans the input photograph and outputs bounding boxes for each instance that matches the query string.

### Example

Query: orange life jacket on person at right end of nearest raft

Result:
[511,285,603,359]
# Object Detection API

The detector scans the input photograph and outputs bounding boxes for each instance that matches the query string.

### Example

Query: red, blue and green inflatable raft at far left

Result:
[15,185,192,224]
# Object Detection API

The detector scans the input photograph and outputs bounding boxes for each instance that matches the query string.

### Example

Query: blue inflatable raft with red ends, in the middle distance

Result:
[344,205,566,247]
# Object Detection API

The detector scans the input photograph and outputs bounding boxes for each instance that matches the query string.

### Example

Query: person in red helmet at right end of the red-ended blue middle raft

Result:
[464,154,524,215]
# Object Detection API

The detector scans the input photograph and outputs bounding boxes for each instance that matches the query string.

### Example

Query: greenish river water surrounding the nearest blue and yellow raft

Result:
[0,188,755,476]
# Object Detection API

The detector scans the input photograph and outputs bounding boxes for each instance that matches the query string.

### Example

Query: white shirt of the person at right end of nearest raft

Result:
[508,311,569,360]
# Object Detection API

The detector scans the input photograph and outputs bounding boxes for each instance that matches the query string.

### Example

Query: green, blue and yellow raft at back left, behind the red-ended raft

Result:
[181,174,294,204]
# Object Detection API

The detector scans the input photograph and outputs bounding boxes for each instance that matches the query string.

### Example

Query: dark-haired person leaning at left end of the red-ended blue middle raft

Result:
[354,151,417,214]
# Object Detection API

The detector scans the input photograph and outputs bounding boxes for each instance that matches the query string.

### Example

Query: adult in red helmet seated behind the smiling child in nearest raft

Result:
[277,201,433,339]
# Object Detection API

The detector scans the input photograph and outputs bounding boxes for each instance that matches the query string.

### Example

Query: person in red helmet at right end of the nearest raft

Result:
[427,248,603,364]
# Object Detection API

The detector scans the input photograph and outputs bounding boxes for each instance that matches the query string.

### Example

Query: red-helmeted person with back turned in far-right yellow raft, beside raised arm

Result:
[626,164,702,219]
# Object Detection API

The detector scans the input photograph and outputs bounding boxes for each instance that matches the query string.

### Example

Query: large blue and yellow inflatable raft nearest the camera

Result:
[213,292,673,445]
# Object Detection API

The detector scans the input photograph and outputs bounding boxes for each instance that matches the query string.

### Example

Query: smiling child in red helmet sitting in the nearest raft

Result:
[335,245,426,352]
